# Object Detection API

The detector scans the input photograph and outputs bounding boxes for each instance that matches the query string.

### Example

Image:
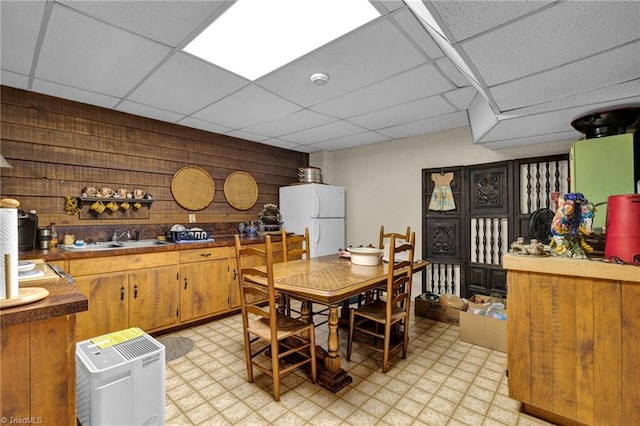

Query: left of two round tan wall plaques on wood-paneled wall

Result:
[171,166,215,210]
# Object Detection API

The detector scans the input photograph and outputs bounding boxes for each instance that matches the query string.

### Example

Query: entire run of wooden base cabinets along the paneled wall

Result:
[68,242,282,340]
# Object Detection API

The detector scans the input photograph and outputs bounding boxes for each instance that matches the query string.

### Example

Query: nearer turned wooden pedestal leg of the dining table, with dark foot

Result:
[318,305,353,392]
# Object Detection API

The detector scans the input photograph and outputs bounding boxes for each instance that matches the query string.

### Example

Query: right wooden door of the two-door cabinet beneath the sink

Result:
[129,266,180,331]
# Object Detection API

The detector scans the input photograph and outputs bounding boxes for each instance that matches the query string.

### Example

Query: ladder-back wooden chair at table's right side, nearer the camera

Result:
[347,232,416,373]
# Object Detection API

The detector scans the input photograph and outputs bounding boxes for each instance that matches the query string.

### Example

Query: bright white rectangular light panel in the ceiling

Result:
[184,0,380,80]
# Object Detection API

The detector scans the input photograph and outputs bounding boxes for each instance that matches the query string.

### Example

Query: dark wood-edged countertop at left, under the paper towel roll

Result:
[0,278,89,327]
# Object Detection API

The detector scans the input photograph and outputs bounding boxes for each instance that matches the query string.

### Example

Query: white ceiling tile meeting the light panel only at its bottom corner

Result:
[193,85,300,129]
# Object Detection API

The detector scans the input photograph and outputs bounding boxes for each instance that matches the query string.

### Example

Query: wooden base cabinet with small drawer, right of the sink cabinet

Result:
[180,247,230,322]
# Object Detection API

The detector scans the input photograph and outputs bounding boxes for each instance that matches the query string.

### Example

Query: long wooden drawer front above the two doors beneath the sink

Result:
[69,251,180,276]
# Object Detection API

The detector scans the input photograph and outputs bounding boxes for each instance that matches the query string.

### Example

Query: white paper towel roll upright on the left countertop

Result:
[0,208,19,299]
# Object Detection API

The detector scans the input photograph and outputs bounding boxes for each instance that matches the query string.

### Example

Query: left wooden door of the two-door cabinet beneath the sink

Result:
[76,273,129,341]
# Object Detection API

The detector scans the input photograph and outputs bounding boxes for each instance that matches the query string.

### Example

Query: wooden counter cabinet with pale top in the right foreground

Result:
[503,255,640,425]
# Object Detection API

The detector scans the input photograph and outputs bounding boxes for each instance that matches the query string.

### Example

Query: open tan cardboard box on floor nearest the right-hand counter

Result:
[460,302,507,352]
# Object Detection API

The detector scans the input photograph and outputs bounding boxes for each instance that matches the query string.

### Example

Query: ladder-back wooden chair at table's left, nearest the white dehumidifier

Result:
[235,235,317,401]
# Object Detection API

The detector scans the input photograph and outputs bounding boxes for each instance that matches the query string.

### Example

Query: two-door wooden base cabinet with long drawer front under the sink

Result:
[69,252,180,340]
